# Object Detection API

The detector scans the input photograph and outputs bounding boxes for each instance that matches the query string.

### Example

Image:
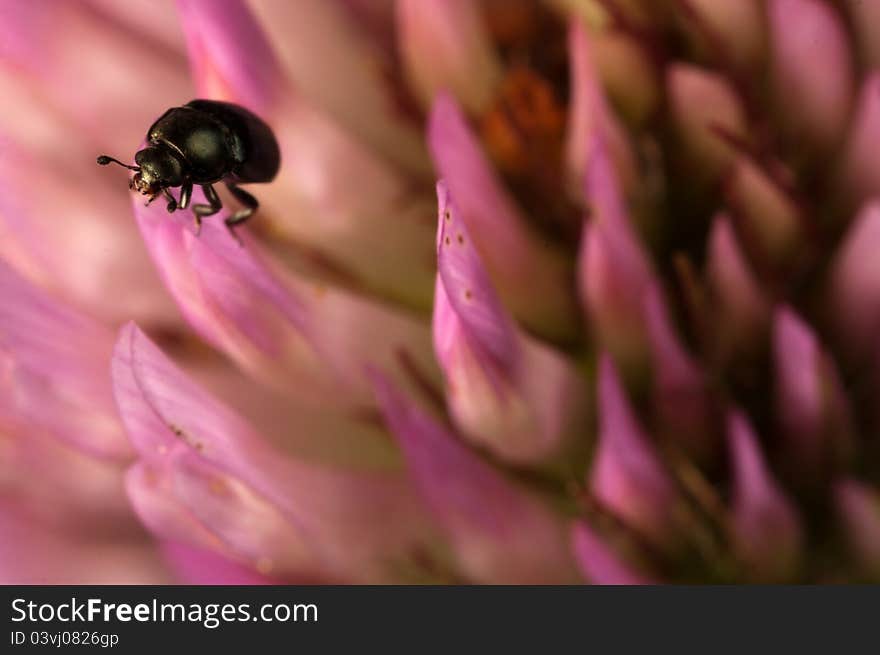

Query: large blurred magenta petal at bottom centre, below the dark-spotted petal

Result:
[374,375,576,584]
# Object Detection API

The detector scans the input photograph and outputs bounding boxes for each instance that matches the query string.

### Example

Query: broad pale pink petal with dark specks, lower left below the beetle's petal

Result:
[113,325,446,581]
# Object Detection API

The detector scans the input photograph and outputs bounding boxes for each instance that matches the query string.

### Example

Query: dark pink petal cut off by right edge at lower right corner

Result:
[834,479,880,579]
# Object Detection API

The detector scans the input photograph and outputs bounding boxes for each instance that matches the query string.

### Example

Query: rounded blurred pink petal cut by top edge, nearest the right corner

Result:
[769,0,853,148]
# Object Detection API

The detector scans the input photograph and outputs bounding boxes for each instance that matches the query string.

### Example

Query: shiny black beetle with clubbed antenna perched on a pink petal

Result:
[98,100,281,237]
